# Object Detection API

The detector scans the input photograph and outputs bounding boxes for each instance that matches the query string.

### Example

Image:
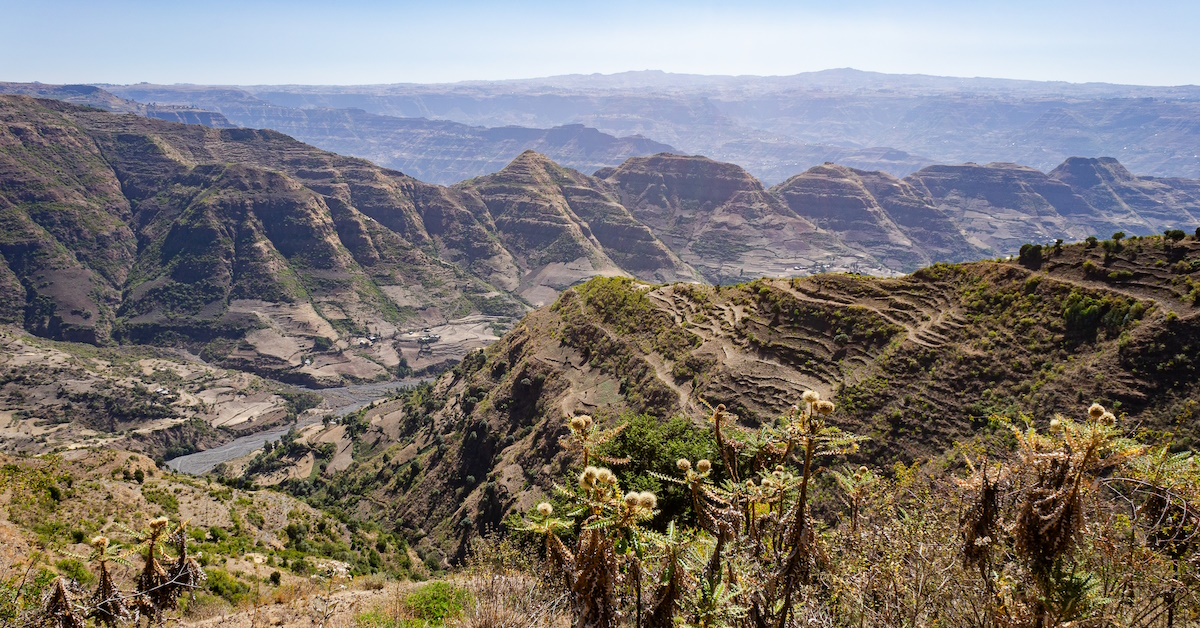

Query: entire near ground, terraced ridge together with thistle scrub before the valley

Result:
[0,233,1200,627]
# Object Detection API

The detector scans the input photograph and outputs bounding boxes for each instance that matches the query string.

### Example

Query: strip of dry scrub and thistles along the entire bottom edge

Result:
[5,391,1200,627]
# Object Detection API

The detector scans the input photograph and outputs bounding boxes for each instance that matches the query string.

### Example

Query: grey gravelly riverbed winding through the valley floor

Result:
[167,377,433,476]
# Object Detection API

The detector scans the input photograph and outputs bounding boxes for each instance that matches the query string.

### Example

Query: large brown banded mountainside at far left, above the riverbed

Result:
[0,96,524,382]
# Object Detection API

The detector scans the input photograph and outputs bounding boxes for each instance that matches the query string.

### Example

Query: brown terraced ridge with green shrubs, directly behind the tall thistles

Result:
[251,237,1200,554]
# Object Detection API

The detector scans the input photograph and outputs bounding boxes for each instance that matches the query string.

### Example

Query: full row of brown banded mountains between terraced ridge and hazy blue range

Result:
[0,94,1200,383]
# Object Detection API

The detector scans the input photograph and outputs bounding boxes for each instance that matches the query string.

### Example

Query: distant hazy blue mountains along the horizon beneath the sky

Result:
[102,68,1200,185]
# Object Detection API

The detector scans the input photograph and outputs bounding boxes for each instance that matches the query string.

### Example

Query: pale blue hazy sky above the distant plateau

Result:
[0,0,1200,85]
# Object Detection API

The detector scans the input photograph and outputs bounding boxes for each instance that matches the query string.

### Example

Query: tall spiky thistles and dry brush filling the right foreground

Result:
[514,391,1200,628]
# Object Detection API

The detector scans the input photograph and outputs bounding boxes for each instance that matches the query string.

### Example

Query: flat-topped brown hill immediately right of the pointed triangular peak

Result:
[596,154,846,283]
